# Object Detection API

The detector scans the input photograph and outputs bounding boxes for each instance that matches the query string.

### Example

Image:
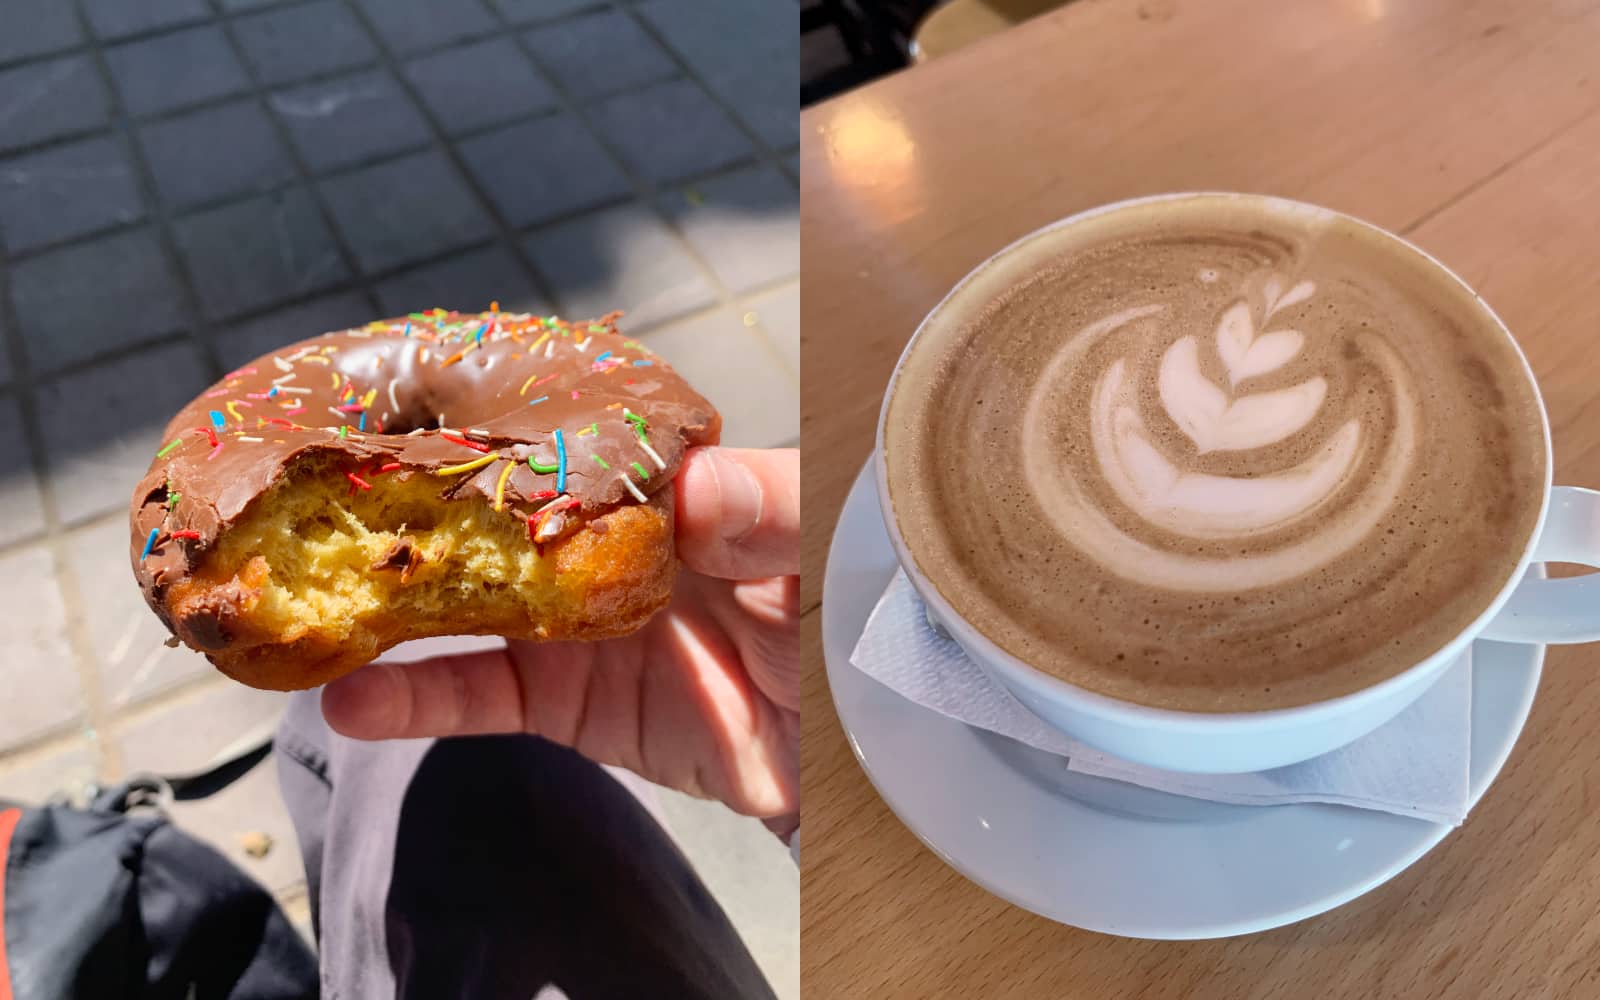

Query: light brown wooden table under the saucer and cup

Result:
[800,0,1600,1000]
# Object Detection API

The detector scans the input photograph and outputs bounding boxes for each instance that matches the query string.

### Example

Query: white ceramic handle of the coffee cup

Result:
[1478,486,1600,643]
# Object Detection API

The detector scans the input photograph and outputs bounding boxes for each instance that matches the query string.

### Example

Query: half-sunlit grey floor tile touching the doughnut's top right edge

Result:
[526,203,717,330]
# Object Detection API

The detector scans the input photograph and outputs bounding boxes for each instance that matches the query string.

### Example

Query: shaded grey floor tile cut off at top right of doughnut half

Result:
[637,0,800,147]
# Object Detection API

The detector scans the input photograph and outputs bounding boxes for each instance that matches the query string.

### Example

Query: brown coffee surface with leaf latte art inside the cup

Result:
[883,197,1547,712]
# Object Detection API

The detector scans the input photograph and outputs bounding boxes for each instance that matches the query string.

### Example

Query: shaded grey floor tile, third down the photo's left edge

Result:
[0,136,144,253]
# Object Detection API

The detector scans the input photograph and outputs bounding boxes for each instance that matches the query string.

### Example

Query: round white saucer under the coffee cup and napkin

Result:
[822,466,1544,939]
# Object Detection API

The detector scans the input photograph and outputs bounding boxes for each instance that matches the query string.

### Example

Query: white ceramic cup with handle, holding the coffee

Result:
[875,194,1600,773]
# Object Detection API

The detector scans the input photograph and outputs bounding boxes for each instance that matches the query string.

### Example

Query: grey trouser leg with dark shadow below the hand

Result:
[274,691,773,1000]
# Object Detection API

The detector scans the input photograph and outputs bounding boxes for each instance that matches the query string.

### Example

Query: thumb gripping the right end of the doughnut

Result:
[677,448,800,579]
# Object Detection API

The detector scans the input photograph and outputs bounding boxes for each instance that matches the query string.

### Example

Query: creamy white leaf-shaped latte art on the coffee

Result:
[1022,267,1416,590]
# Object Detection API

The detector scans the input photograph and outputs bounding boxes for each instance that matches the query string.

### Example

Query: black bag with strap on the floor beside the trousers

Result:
[0,742,318,1000]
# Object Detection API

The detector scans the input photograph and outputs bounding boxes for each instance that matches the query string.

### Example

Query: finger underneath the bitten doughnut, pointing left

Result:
[322,650,523,739]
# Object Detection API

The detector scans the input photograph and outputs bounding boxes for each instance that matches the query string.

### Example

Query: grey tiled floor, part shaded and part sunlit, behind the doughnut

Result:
[0,0,800,995]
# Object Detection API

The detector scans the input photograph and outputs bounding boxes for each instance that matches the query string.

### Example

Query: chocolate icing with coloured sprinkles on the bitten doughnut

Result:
[130,310,722,611]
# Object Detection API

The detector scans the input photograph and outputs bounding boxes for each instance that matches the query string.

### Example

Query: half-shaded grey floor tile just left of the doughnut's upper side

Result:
[37,344,211,528]
